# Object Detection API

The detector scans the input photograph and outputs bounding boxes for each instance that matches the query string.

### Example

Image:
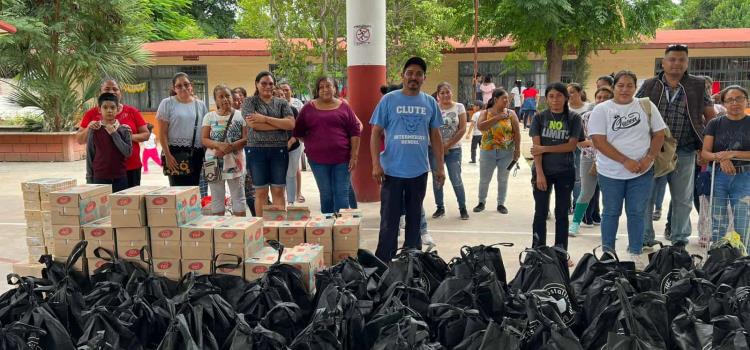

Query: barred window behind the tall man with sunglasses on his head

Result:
[654,56,750,89]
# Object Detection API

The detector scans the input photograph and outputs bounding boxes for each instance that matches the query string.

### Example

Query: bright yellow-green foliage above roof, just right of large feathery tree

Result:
[144,0,206,41]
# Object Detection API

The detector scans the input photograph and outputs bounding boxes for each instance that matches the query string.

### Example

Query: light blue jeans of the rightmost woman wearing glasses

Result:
[711,169,750,246]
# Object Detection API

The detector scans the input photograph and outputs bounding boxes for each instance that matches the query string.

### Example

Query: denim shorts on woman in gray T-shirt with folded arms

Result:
[245,147,289,188]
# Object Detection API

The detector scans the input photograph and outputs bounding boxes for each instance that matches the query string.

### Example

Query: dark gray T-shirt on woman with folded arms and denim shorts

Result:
[242,96,294,148]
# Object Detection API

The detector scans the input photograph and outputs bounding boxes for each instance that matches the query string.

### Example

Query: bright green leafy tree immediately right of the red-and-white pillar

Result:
[386,0,456,82]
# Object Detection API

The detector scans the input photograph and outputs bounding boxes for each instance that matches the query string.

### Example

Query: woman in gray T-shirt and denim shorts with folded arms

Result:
[242,71,294,216]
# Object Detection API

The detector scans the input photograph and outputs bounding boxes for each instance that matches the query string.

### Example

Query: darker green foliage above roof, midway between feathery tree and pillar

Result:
[190,0,239,38]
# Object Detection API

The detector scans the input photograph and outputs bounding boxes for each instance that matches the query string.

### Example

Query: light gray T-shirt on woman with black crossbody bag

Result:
[156,96,208,148]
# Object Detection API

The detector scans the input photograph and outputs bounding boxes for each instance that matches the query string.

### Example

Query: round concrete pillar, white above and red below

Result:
[346,0,386,202]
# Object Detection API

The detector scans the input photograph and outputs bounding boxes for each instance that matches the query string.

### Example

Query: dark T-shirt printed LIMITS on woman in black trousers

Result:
[529,110,585,176]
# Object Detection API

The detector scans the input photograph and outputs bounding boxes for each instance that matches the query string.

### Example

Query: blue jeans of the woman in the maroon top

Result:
[307,158,351,214]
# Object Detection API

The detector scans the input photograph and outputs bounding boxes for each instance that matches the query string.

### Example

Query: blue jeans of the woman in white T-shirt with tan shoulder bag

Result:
[599,168,654,254]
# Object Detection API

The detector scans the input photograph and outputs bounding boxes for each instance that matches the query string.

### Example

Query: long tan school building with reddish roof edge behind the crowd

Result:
[135,28,750,112]
